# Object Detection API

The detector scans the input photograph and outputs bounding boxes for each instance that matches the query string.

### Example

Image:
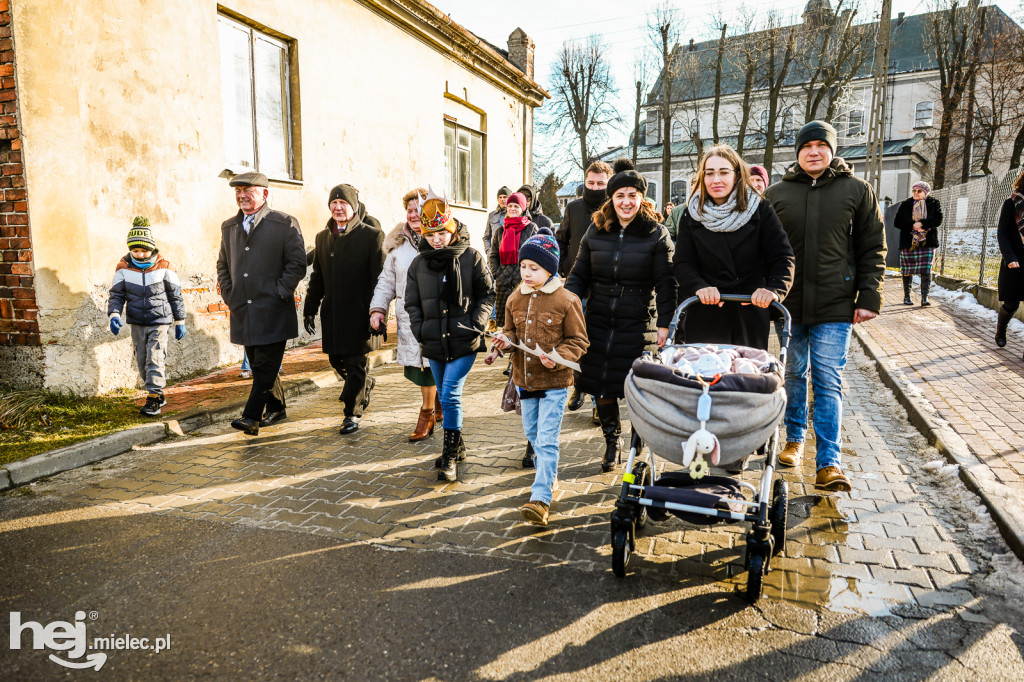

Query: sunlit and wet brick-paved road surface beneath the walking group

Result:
[14,349,1007,622]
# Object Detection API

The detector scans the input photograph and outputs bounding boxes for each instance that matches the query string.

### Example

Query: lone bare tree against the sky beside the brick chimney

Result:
[542,36,621,170]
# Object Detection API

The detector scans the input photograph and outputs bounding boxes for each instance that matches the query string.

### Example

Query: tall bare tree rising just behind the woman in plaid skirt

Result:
[926,0,985,189]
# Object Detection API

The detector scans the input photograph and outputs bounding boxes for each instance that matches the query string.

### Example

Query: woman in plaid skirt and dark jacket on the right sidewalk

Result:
[893,180,942,306]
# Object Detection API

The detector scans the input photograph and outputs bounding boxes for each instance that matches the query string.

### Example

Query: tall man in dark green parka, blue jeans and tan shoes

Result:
[765,121,886,491]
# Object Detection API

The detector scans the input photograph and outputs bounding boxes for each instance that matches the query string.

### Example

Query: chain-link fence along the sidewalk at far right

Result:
[930,168,1021,287]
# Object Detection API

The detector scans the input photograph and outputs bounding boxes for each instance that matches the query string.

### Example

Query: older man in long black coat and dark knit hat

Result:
[302,184,384,434]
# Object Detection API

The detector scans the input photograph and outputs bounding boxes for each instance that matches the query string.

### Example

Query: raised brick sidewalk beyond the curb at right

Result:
[864,278,1024,495]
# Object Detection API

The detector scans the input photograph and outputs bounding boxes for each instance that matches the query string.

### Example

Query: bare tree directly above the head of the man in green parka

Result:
[799,0,874,121]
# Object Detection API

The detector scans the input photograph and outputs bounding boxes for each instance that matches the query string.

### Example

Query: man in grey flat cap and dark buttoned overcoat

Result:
[217,173,306,435]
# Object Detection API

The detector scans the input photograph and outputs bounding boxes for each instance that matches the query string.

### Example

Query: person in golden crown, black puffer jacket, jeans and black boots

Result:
[406,193,495,481]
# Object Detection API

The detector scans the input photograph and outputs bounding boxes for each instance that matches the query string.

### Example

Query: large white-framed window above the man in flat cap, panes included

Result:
[217,14,295,179]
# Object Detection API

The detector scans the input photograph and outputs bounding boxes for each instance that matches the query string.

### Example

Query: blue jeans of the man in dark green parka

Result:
[785,323,853,469]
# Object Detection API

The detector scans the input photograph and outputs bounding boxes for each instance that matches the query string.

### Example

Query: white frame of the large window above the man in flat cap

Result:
[217,14,297,180]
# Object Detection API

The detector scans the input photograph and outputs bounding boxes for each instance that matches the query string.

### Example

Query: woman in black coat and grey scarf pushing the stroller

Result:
[674,144,795,349]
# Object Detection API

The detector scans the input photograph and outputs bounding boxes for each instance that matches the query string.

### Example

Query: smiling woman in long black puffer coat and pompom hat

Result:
[565,160,676,471]
